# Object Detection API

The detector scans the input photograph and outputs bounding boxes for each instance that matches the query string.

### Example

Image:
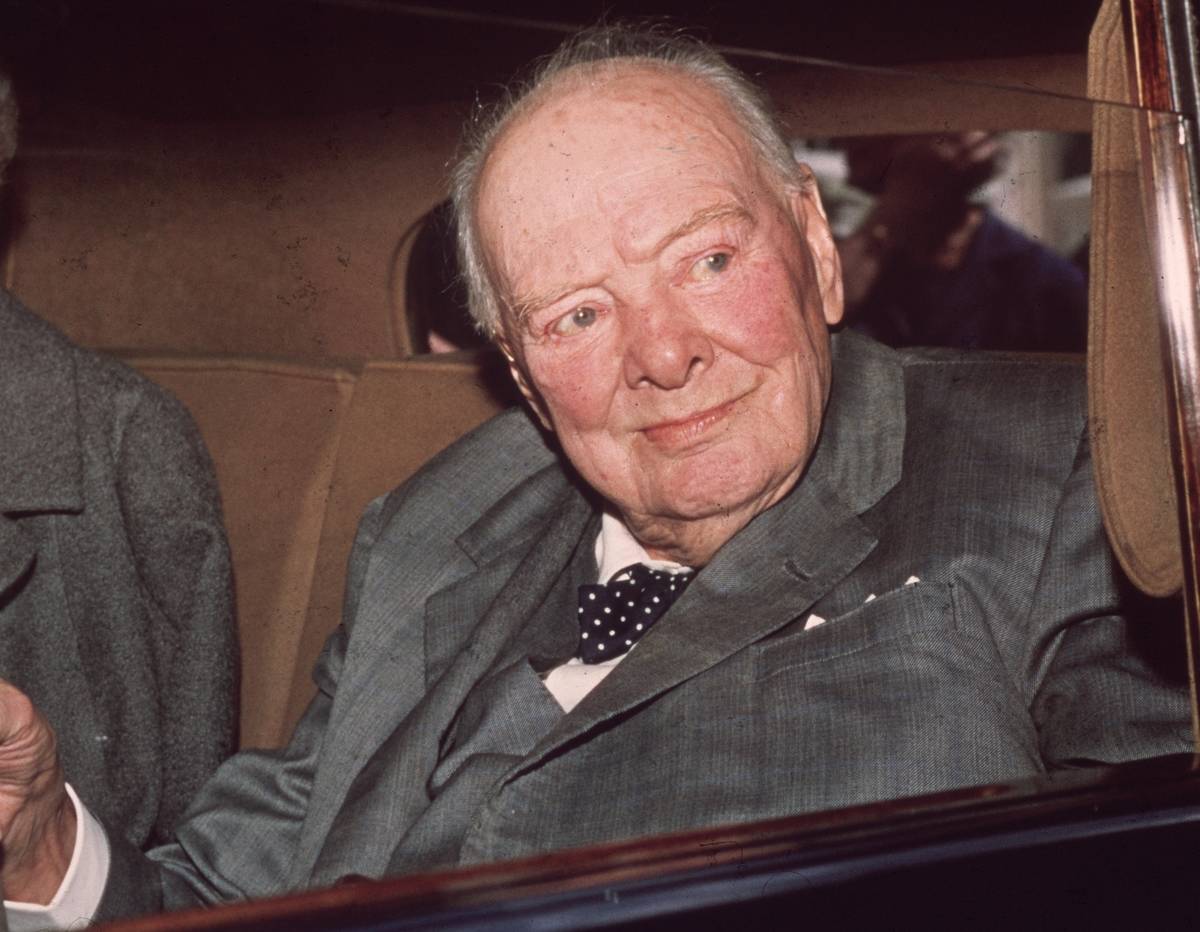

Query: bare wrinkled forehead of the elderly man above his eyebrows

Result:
[476,62,761,272]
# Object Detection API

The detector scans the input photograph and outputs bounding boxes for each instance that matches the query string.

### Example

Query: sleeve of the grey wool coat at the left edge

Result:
[115,392,238,842]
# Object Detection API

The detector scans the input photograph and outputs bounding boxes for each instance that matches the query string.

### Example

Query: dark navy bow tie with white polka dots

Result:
[580,563,696,663]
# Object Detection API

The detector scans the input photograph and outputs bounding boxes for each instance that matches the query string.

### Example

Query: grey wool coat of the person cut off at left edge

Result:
[0,290,238,846]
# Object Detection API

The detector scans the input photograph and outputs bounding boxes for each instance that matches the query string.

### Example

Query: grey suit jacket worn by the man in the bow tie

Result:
[102,333,1190,916]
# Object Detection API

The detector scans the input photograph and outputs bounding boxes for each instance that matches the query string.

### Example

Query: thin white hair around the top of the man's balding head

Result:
[450,24,806,338]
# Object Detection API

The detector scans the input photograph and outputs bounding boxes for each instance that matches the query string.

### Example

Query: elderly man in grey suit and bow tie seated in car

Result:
[0,25,1189,919]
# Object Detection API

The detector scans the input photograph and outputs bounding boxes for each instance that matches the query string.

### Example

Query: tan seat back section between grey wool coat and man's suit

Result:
[128,356,355,747]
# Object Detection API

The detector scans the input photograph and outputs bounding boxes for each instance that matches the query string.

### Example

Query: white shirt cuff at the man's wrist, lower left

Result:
[4,783,112,932]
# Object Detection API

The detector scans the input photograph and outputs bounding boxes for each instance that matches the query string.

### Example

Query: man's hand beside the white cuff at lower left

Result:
[0,680,76,903]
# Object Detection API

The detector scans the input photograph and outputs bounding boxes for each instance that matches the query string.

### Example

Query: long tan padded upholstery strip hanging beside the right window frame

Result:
[1087,0,1183,595]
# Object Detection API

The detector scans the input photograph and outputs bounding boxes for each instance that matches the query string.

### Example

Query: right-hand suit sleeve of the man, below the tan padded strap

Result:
[1027,437,1192,769]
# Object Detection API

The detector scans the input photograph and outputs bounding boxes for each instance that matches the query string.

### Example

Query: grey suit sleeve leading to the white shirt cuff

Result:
[96,501,380,921]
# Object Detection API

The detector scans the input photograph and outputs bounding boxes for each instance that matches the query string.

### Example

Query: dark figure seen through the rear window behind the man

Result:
[839,132,1087,351]
